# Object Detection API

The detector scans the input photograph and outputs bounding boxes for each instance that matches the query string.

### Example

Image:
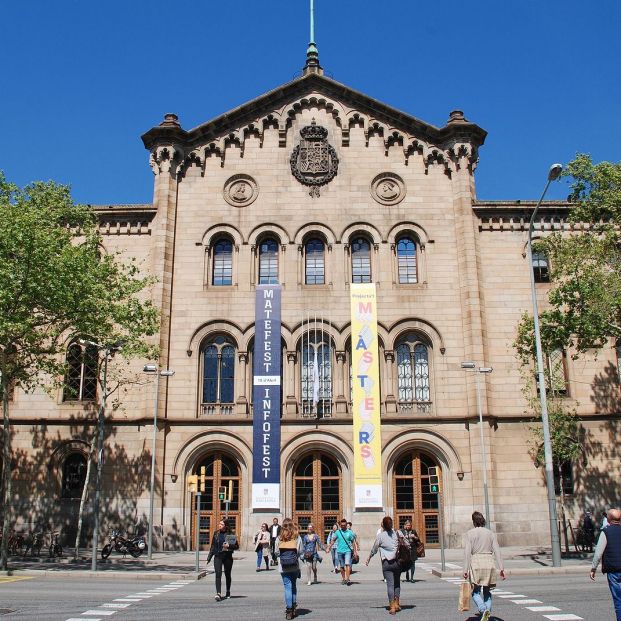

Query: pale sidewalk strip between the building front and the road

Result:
[0,547,592,580]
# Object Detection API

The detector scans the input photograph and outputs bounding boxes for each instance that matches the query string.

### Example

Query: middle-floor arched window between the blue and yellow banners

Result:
[300,330,332,418]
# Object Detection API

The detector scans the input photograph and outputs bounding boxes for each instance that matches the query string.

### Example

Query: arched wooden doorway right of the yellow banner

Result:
[393,451,444,548]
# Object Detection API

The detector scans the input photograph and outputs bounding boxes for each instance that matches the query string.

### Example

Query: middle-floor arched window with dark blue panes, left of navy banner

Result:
[202,336,235,414]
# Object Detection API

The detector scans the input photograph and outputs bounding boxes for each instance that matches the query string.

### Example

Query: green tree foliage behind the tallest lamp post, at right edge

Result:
[516,154,621,360]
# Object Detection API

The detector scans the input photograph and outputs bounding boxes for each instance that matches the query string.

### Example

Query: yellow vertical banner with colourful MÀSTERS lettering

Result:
[350,283,383,508]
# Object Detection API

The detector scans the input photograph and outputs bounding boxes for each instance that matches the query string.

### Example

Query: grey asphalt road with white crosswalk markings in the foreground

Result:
[0,558,614,621]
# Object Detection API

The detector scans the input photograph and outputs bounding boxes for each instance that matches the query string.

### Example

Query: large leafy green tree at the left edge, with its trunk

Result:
[0,173,158,570]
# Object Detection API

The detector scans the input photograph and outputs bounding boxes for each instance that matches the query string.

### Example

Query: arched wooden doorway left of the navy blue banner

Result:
[191,453,241,550]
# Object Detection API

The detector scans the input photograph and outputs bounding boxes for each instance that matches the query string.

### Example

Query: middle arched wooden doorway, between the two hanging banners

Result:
[293,451,342,541]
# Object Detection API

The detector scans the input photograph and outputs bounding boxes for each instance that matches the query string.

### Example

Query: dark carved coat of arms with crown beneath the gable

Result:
[291,119,339,196]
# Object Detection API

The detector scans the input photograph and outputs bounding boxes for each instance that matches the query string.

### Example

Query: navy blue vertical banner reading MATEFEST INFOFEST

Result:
[252,285,282,510]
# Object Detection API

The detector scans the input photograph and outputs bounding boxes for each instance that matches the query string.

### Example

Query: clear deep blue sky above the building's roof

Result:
[0,0,621,204]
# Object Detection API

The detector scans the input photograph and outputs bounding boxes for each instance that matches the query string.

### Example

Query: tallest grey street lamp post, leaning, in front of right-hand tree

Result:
[527,164,563,567]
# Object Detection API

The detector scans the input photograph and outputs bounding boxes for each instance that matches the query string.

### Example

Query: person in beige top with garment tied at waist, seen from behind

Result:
[464,511,506,621]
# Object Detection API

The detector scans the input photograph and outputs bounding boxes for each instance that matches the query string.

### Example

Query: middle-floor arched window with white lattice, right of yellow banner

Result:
[397,334,431,412]
